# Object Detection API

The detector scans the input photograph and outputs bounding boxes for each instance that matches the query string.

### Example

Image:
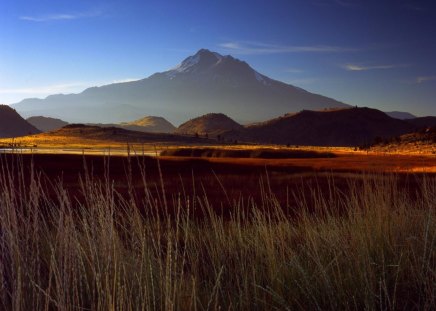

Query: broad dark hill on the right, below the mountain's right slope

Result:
[224,108,415,146]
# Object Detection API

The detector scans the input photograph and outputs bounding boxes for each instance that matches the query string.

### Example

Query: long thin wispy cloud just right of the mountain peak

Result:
[218,42,357,55]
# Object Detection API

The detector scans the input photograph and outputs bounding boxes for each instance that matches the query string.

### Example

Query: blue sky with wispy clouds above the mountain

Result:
[0,0,436,116]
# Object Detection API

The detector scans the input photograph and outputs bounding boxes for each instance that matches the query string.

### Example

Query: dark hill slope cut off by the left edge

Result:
[0,105,40,138]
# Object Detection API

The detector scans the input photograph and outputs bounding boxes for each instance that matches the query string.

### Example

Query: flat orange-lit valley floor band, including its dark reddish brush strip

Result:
[0,140,436,173]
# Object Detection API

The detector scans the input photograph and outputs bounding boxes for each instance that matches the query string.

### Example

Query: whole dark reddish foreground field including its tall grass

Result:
[0,155,436,310]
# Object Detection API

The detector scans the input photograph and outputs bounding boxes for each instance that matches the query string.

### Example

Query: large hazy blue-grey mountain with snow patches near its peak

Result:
[14,49,348,124]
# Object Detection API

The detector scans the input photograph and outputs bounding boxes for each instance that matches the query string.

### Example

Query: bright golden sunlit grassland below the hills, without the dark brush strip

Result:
[0,131,436,172]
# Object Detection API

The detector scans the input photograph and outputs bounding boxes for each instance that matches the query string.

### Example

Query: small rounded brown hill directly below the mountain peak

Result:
[175,113,243,136]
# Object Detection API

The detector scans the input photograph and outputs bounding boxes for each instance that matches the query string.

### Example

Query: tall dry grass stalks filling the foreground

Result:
[0,157,436,310]
